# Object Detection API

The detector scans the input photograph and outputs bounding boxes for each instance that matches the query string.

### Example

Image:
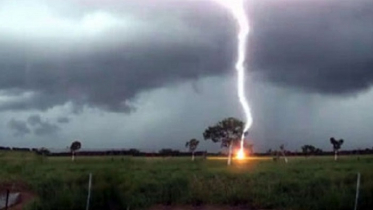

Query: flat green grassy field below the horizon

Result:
[0,152,373,210]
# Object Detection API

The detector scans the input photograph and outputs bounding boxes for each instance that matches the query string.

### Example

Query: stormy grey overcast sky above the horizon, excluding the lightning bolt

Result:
[0,0,373,151]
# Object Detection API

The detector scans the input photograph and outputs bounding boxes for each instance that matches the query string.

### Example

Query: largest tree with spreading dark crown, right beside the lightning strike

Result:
[203,117,244,165]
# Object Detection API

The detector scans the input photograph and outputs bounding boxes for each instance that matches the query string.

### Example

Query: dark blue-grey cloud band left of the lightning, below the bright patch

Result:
[0,23,231,112]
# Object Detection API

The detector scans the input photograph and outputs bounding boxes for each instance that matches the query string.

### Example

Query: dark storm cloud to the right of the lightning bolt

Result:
[251,0,373,94]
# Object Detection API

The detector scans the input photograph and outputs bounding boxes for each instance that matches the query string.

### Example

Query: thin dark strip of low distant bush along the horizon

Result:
[0,146,373,157]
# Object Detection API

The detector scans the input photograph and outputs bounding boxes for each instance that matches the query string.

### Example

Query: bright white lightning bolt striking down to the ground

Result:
[215,0,253,153]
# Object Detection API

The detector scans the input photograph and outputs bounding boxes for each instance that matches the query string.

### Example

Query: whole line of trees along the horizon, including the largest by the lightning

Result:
[0,117,373,159]
